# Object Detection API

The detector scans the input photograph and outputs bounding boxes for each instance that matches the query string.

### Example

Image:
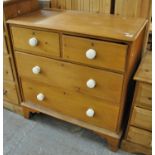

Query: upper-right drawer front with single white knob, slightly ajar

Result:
[63,35,127,72]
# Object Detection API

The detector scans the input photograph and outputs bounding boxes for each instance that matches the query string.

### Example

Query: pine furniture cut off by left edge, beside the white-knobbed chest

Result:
[3,0,30,114]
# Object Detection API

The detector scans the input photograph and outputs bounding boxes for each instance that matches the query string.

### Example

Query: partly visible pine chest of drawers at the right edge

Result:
[122,52,152,154]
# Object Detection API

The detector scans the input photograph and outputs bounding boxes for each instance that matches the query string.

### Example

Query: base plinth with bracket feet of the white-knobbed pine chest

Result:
[22,102,122,151]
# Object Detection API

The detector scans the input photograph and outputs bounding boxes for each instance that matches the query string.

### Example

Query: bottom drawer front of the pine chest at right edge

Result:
[127,127,152,147]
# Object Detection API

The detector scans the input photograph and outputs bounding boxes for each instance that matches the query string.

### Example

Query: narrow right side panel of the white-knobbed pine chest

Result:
[115,29,145,131]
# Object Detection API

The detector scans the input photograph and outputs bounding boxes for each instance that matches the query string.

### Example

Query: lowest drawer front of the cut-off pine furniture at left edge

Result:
[3,81,18,104]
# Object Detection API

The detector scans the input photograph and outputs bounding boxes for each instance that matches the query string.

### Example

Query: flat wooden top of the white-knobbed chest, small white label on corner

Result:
[8,10,147,42]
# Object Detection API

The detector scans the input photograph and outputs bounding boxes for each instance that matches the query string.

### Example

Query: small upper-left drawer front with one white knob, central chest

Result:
[11,27,60,57]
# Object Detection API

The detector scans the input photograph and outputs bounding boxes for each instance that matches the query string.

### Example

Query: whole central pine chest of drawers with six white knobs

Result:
[8,10,146,150]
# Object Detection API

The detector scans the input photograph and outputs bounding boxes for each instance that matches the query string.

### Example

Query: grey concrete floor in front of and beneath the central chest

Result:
[3,110,131,155]
